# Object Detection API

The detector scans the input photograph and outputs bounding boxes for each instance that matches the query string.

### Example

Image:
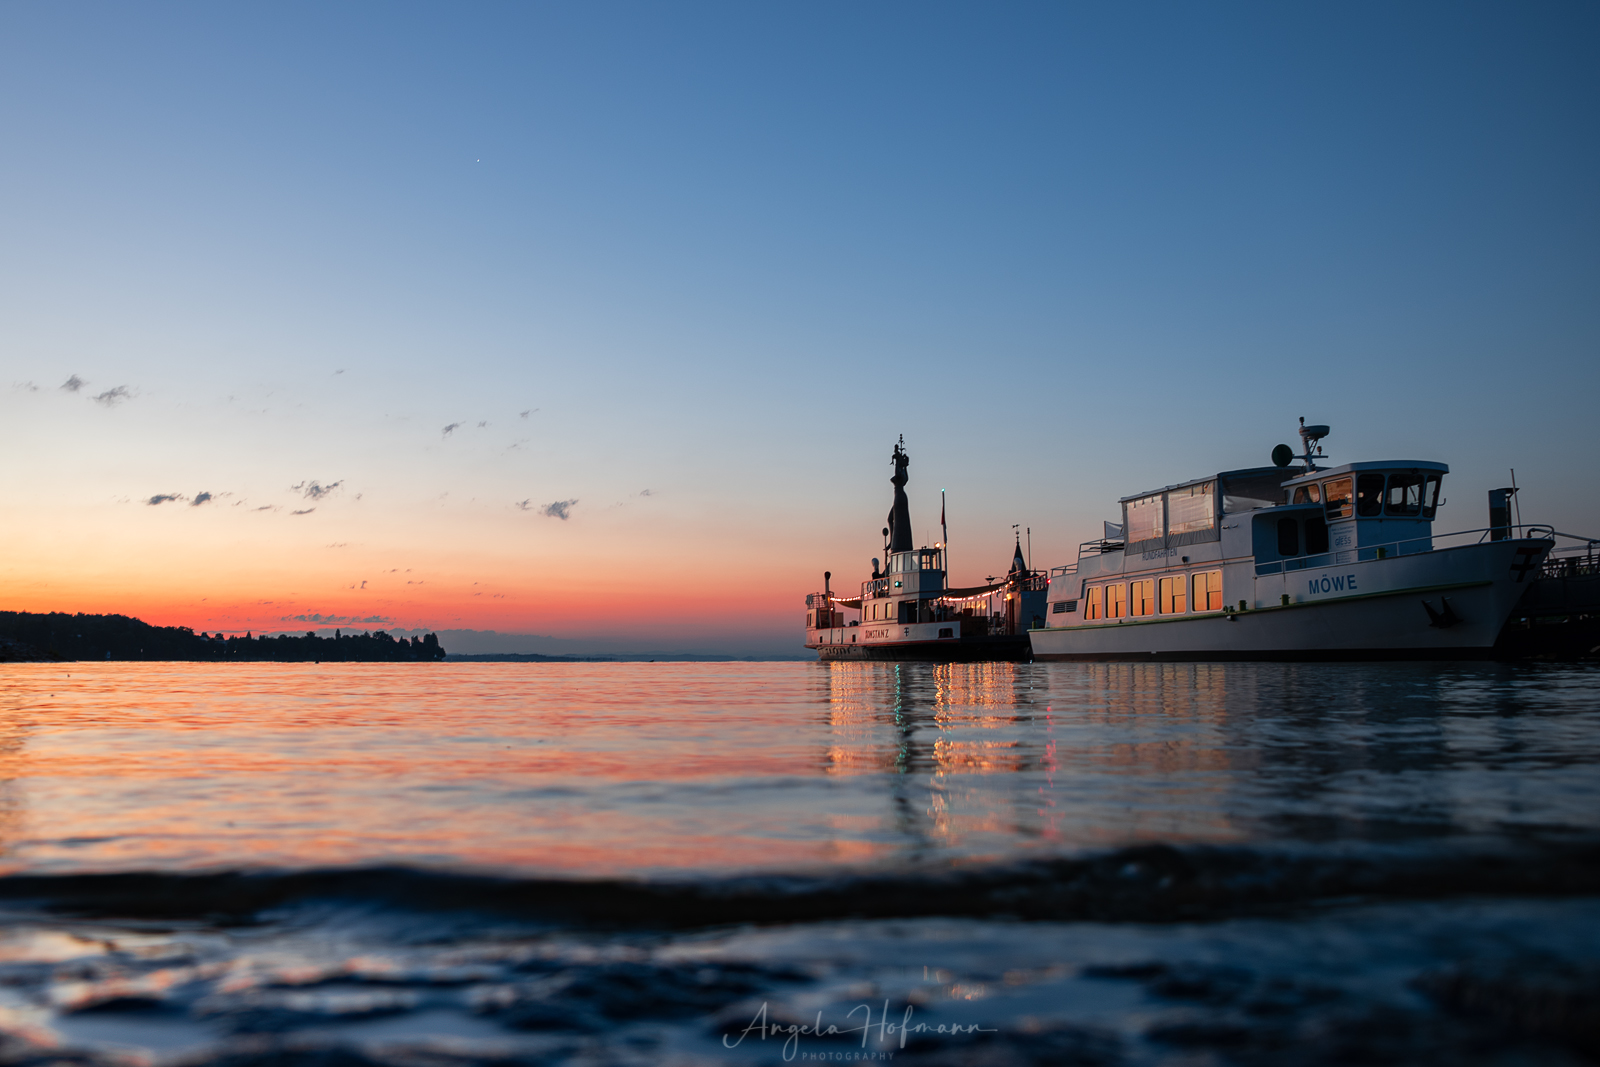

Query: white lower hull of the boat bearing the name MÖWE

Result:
[1029,539,1550,659]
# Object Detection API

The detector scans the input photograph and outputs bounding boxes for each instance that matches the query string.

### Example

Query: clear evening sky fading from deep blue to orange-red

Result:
[0,2,1600,654]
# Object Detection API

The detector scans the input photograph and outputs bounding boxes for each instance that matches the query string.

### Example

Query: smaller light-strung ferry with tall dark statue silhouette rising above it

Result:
[805,438,1048,661]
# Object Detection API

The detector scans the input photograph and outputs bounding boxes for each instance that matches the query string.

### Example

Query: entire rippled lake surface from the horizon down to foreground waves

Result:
[0,664,1600,1064]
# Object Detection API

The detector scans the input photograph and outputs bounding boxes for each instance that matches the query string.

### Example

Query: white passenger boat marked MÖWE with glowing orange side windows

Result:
[1029,419,1555,661]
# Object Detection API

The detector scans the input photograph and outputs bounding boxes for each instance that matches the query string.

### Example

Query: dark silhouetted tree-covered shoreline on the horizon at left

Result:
[0,611,445,662]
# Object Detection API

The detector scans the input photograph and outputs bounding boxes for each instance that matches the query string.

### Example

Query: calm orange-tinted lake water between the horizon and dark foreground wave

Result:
[0,662,1600,875]
